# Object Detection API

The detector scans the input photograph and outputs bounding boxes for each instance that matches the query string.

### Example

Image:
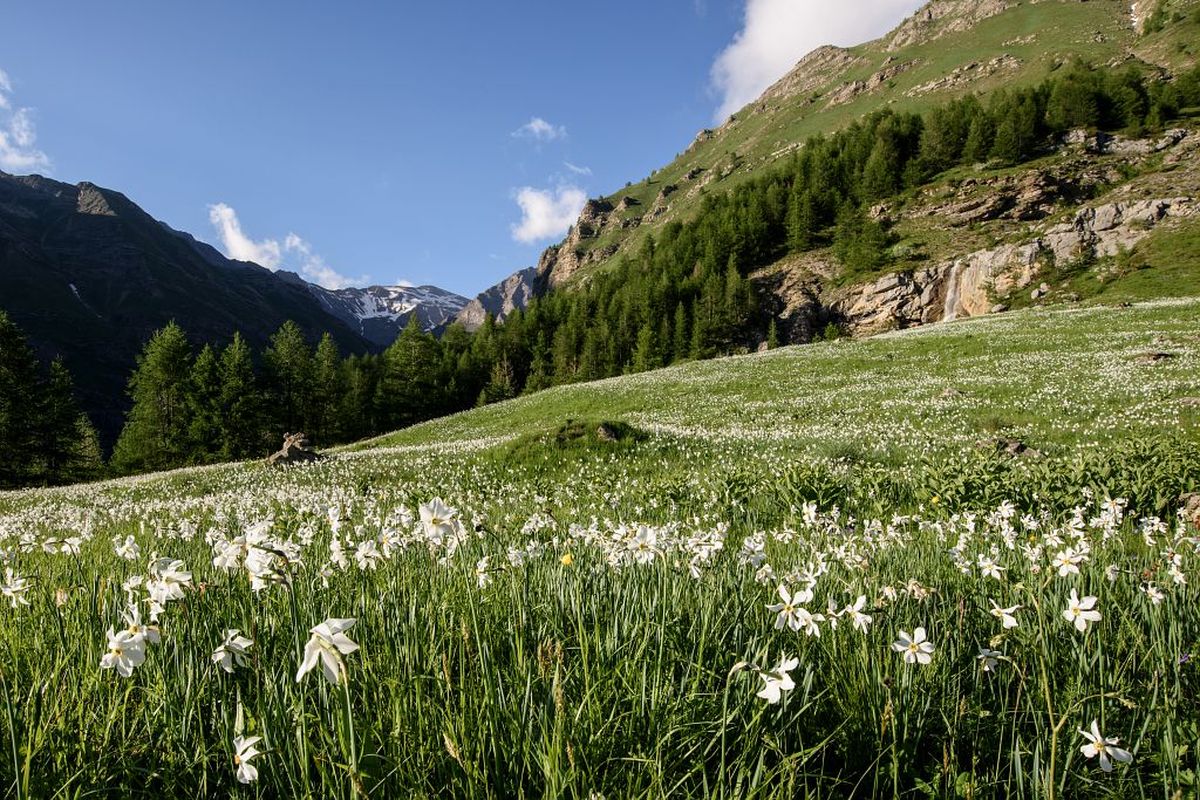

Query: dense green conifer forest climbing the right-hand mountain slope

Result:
[470,64,1200,397]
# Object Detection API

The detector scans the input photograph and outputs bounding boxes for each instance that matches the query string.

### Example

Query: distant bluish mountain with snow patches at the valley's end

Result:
[292,272,468,349]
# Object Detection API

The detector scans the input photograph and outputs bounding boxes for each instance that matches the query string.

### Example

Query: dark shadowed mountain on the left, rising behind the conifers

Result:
[0,173,371,444]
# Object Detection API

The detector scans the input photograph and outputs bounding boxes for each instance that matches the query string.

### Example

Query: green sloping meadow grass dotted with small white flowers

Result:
[0,300,1200,800]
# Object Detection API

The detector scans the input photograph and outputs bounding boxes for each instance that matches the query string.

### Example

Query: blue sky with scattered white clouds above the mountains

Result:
[0,0,919,295]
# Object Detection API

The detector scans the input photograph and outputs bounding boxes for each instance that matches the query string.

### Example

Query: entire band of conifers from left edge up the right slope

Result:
[9,65,1200,485]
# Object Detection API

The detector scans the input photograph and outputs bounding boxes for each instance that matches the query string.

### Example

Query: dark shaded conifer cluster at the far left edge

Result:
[0,311,103,488]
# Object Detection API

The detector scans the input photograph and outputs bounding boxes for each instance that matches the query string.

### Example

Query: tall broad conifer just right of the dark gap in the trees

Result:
[113,321,192,473]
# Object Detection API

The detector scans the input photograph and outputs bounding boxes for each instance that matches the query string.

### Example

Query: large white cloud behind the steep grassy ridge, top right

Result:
[710,0,920,122]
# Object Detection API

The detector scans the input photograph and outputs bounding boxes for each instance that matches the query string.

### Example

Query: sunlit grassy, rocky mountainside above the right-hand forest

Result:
[538,0,1200,288]
